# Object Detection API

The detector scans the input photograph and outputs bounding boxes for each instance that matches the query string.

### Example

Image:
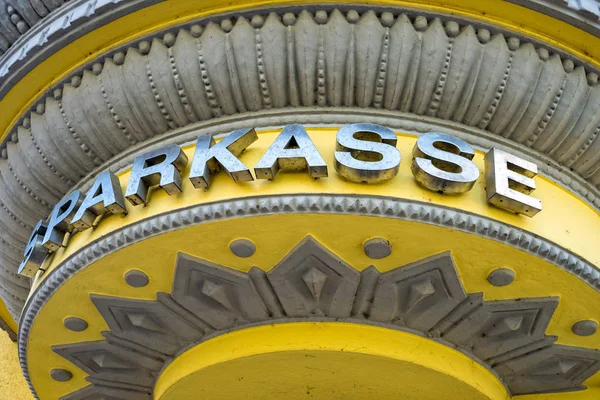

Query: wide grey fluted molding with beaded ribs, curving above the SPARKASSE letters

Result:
[0,10,600,315]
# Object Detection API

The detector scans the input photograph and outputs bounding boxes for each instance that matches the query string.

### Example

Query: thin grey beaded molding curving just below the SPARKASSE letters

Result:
[19,194,600,398]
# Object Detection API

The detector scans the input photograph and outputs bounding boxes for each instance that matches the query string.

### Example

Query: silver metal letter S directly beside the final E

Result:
[411,132,479,194]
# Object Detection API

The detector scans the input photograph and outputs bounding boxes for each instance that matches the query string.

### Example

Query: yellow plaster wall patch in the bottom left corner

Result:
[0,331,33,400]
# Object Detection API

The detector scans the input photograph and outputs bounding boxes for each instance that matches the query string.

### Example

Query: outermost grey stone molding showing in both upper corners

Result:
[0,0,600,98]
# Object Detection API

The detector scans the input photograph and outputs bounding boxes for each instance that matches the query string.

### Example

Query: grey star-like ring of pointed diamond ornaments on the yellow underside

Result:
[47,236,600,400]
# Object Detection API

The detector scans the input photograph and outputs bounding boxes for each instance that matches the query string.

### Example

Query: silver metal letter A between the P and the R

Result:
[72,171,127,231]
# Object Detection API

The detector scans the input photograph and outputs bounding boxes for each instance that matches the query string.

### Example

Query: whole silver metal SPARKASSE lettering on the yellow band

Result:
[19,123,542,277]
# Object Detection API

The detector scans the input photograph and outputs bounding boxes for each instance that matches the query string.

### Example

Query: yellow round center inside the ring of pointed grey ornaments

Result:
[154,322,510,400]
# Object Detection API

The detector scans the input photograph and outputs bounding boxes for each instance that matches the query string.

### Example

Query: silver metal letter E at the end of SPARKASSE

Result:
[485,148,542,217]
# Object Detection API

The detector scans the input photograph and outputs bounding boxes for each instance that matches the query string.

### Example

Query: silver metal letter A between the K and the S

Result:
[254,124,327,179]
